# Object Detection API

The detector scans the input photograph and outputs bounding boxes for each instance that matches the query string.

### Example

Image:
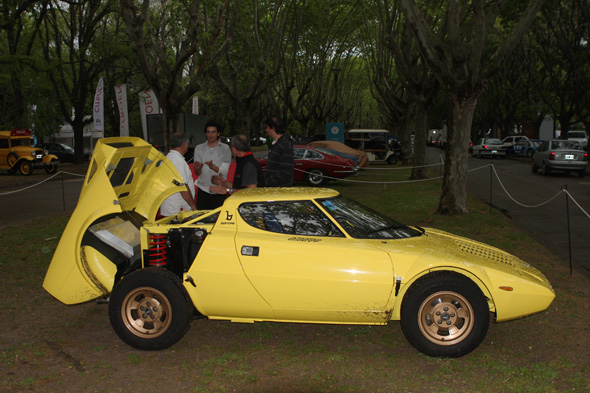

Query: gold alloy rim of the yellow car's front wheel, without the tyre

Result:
[418,291,474,345]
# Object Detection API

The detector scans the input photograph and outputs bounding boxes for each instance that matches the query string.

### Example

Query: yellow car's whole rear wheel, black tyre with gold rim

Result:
[109,268,193,350]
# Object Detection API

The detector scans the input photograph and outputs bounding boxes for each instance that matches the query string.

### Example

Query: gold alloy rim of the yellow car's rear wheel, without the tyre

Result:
[121,287,172,338]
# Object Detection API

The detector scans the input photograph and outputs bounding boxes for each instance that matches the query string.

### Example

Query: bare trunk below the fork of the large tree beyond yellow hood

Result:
[436,93,478,215]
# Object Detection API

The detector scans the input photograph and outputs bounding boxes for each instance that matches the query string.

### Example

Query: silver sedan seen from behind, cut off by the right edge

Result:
[531,139,588,177]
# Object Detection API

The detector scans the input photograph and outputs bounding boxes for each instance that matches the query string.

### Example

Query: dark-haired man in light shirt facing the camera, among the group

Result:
[194,121,231,210]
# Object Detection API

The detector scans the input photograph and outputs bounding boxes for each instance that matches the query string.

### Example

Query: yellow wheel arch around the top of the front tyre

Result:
[391,266,496,320]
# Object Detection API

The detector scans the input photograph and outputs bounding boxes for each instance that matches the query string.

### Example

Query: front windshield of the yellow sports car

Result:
[319,196,422,239]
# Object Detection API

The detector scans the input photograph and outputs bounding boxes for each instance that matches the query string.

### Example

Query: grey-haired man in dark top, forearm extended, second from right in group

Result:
[210,134,265,195]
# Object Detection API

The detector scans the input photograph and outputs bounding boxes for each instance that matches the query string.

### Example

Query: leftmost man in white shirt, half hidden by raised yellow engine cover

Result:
[160,132,197,217]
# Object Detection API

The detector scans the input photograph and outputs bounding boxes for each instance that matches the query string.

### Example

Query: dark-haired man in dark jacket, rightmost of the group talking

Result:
[266,116,295,187]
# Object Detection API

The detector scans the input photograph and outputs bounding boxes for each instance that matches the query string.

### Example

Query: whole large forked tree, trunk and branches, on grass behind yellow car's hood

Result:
[399,0,546,215]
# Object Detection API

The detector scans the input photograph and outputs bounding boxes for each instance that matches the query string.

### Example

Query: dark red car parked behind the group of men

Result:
[256,145,358,187]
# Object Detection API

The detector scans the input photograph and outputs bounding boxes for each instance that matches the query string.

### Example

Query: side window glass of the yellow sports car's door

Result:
[238,201,344,237]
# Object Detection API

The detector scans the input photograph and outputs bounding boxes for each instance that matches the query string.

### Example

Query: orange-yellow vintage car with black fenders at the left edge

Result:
[0,129,59,176]
